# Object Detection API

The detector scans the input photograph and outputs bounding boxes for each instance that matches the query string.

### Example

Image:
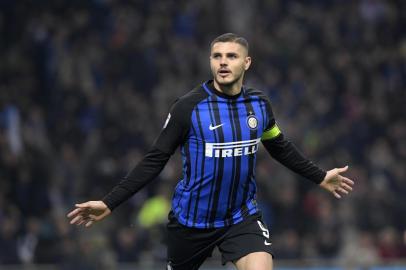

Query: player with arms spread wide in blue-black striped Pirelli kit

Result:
[68,33,354,270]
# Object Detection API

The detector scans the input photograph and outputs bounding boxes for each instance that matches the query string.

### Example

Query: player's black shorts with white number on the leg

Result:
[167,212,272,270]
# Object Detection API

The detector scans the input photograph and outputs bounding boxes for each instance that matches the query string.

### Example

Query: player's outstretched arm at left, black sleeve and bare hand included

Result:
[68,98,189,227]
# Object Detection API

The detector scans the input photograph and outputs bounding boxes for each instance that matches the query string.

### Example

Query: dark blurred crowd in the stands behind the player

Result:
[0,0,406,269]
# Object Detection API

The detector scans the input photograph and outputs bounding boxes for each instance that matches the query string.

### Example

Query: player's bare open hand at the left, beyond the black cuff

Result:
[68,201,111,227]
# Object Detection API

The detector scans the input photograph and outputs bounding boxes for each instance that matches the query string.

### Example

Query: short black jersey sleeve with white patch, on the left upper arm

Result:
[154,99,190,155]
